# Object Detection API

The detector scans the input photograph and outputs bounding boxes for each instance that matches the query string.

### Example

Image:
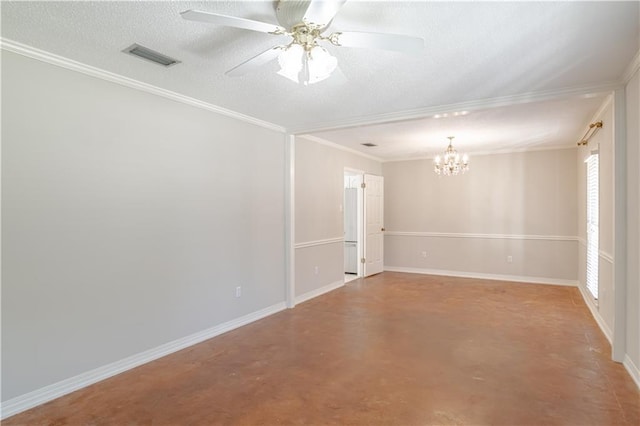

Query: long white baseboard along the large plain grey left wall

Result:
[0,302,286,419]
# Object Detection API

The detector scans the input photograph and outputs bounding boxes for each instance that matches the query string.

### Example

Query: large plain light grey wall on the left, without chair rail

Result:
[2,51,285,401]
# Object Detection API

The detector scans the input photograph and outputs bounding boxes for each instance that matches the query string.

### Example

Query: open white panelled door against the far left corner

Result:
[364,175,384,277]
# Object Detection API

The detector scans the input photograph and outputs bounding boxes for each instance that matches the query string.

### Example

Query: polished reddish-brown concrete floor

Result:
[2,273,640,426]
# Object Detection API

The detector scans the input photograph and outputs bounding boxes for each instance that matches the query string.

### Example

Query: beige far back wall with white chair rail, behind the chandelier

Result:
[383,149,577,282]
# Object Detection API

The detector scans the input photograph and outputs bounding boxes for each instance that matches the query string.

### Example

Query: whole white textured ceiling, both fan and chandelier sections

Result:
[1,0,640,159]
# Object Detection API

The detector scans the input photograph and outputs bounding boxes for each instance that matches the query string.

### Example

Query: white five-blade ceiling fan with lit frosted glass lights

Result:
[181,0,424,85]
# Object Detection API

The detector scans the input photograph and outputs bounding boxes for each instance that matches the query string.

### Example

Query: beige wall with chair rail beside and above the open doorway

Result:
[295,137,381,297]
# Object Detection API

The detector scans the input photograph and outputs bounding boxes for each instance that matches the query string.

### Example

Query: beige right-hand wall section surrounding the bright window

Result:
[576,98,615,339]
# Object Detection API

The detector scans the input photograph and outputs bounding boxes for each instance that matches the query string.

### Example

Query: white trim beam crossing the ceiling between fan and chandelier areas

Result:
[289,81,620,134]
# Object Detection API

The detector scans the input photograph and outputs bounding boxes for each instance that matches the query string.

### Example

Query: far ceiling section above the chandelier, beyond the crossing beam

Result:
[311,93,606,161]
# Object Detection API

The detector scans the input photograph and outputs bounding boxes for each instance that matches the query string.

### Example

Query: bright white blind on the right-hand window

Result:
[587,154,600,300]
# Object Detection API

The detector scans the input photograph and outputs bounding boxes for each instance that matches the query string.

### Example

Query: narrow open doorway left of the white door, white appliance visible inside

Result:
[343,169,364,283]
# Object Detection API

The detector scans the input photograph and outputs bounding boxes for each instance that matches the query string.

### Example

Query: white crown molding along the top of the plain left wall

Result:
[0,38,286,133]
